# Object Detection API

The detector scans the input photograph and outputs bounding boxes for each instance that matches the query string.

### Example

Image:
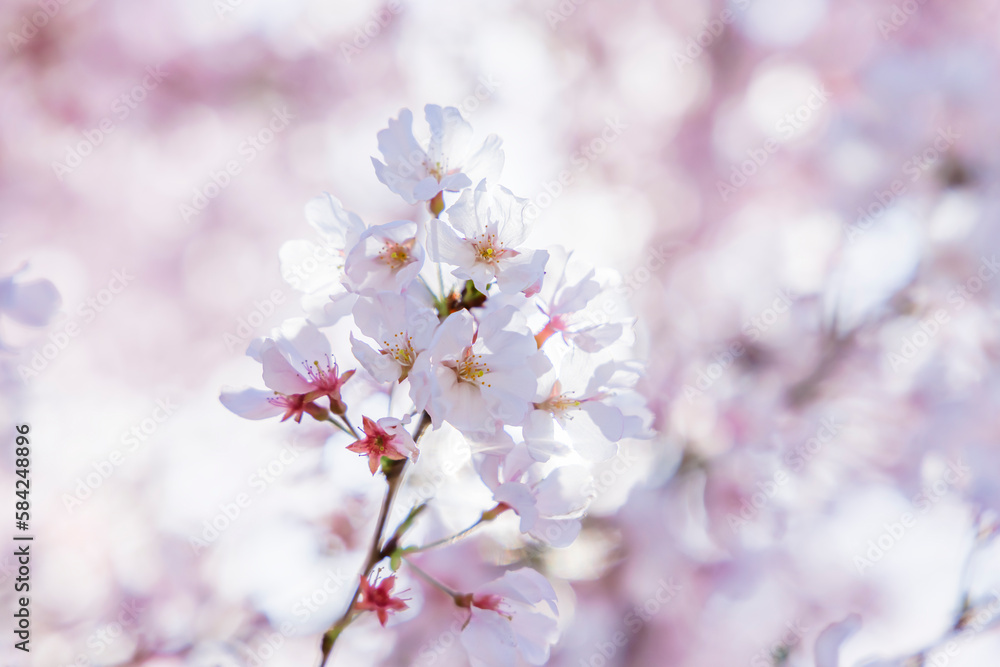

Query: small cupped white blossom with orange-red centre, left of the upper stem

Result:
[344,220,424,293]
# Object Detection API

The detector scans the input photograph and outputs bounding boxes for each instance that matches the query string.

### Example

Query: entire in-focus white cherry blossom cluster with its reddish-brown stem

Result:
[221,105,651,665]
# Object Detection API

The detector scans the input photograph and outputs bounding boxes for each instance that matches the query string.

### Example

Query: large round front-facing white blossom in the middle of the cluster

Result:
[410,306,548,434]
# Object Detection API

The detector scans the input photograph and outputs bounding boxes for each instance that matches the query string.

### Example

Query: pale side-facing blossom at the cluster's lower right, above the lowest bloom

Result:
[477,443,592,547]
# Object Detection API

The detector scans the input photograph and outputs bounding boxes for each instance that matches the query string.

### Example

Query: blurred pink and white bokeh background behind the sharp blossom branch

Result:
[0,0,1000,667]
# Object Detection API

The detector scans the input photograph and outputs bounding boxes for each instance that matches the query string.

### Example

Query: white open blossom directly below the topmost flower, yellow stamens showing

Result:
[430,180,549,294]
